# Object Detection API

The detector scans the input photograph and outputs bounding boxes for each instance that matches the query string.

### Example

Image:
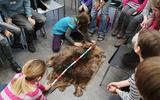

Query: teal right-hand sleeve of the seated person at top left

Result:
[24,0,32,17]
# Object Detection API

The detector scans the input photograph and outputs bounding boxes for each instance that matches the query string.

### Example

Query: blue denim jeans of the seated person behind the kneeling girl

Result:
[88,0,111,36]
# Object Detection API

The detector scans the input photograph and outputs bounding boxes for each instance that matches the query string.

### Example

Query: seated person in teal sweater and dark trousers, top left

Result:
[0,0,46,52]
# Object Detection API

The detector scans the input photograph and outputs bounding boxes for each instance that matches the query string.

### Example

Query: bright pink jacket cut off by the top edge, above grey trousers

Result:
[123,0,148,12]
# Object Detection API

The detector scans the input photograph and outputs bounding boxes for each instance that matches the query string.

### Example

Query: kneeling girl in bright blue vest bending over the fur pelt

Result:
[52,12,93,52]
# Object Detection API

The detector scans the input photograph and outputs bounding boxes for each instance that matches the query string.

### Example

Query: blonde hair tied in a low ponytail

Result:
[12,59,47,95]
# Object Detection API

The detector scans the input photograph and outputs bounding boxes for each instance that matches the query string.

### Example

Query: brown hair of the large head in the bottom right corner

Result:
[135,57,160,100]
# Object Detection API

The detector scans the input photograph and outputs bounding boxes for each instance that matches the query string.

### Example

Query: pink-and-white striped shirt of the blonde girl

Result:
[0,73,46,100]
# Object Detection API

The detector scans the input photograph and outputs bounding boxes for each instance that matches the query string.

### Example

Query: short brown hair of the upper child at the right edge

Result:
[138,29,160,59]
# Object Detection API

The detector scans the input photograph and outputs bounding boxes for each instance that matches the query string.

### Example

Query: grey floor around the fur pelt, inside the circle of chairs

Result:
[0,0,129,100]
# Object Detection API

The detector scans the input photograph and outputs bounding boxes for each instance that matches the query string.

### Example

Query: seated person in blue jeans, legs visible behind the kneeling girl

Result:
[88,0,111,41]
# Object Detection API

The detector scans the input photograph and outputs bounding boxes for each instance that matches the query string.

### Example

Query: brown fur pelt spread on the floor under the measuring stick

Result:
[47,43,104,97]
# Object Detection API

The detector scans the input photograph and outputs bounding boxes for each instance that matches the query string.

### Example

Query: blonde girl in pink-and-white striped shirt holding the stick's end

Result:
[0,59,50,100]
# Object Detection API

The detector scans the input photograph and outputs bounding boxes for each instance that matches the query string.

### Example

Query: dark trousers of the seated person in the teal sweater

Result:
[12,10,46,44]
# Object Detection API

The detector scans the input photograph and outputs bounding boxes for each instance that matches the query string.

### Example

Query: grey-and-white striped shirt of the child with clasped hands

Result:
[118,74,140,100]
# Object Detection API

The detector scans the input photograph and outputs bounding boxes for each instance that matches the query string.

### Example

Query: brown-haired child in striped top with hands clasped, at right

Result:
[107,30,160,100]
